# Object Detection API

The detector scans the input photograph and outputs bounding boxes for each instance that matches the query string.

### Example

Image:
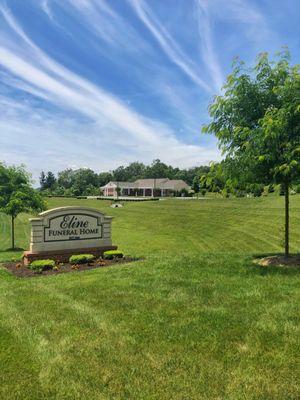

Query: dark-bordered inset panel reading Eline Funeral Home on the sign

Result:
[44,213,102,242]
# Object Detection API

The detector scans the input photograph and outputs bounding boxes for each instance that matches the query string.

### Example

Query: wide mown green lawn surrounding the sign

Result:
[0,196,300,400]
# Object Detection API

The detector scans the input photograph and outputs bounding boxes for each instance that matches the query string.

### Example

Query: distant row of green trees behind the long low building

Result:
[40,160,210,196]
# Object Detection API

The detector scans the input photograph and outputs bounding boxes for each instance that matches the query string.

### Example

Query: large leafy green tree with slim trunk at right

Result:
[203,51,300,257]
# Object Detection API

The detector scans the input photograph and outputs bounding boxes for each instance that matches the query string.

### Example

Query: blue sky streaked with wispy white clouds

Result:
[0,0,300,182]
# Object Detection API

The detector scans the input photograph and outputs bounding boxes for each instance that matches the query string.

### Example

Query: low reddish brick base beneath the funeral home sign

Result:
[22,246,118,266]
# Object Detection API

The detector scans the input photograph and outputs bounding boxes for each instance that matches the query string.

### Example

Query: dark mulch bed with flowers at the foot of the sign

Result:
[3,257,139,278]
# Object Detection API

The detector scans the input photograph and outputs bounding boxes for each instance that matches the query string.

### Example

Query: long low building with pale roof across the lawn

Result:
[101,178,191,197]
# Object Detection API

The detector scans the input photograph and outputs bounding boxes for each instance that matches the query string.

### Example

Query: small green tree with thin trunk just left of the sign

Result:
[0,164,45,250]
